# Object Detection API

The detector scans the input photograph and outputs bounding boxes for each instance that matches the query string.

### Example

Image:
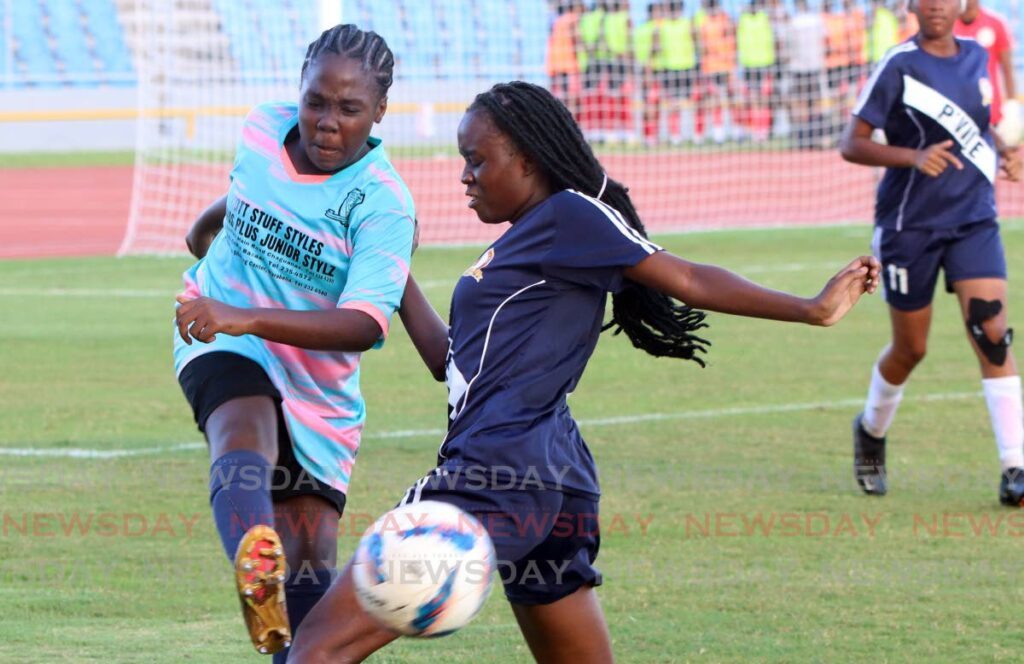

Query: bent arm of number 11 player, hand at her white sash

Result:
[839,116,964,177]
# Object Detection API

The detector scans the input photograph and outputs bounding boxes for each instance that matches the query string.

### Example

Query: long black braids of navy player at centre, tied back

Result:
[468,81,711,367]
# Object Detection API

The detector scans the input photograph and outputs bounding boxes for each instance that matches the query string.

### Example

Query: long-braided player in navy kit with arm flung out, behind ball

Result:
[289,82,879,664]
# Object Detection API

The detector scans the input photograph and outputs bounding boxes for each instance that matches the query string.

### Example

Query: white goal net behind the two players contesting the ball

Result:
[121,0,1024,253]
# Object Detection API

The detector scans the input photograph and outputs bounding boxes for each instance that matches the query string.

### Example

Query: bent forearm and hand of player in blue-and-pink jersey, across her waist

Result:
[174,295,382,352]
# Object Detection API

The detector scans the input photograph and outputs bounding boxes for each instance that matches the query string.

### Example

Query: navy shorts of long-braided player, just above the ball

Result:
[398,467,601,605]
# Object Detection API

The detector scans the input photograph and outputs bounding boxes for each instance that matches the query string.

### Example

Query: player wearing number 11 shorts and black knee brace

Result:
[840,0,1024,505]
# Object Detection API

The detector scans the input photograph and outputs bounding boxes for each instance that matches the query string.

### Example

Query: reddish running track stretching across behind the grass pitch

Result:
[0,151,1024,258]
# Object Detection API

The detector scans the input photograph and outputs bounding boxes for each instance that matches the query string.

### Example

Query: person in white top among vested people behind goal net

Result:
[786,0,825,149]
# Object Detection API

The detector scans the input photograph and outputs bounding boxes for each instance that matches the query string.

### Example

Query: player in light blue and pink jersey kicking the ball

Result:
[174,25,415,651]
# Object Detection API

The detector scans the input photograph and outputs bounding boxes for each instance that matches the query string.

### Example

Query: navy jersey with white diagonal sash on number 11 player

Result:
[853,38,997,231]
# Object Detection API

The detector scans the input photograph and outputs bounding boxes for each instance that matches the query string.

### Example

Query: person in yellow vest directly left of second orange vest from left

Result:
[654,0,699,144]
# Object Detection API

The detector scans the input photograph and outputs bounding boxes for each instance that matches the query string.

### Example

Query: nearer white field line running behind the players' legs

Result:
[0,391,981,459]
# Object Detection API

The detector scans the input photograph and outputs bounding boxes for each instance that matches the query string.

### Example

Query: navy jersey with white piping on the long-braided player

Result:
[439,191,660,496]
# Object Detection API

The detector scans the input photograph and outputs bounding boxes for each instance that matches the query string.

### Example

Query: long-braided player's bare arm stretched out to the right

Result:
[624,251,880,325]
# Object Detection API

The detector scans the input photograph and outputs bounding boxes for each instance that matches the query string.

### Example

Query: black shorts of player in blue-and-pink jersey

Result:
[178,351,345,514]
